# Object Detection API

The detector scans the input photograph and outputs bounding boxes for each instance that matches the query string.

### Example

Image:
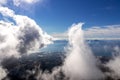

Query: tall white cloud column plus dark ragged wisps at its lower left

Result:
[24,23,104,80]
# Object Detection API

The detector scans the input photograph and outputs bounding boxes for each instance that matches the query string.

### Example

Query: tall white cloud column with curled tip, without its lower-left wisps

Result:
[63,23,103,80]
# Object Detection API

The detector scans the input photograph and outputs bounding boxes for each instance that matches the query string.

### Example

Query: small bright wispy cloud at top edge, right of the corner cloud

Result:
[11,0,48,14]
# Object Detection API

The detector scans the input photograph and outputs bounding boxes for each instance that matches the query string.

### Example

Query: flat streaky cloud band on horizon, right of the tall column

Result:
[84,25,120,39]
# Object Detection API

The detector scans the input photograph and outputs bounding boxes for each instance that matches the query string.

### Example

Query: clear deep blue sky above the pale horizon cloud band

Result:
[2,0,120,33]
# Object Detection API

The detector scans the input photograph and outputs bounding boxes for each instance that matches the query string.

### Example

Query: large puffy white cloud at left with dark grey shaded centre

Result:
[0,7,52,58]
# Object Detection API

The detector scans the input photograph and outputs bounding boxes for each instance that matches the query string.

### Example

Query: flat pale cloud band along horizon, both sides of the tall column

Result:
[51,25,120,39]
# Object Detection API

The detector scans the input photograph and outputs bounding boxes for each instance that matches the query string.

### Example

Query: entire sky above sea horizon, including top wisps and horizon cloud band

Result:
[0,0,120,38]
